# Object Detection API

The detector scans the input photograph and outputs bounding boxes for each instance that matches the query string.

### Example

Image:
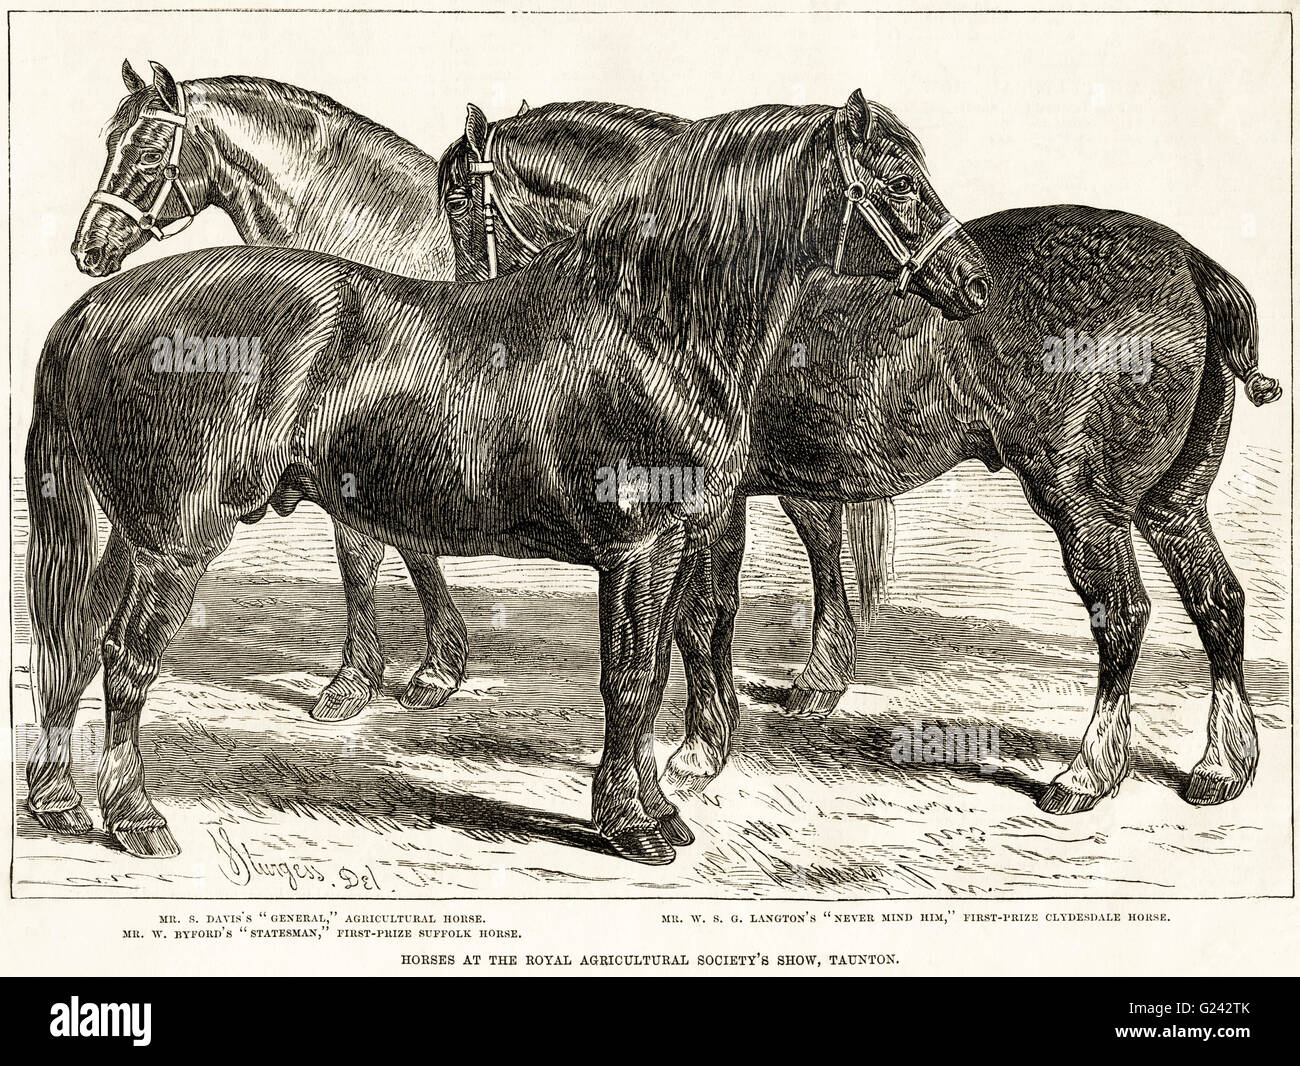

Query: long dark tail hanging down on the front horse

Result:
[26,312,99,710]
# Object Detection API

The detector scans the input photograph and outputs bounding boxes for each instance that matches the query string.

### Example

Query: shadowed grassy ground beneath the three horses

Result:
[13,450,1292,898]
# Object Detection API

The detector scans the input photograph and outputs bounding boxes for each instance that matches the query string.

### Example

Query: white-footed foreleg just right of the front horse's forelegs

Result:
[664,501,745,796]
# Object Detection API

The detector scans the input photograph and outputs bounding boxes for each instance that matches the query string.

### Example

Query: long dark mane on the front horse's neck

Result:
[576,104,833,347]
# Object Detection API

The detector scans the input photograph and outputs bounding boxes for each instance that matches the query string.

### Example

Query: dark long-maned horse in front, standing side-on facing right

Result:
[25,92,987,865]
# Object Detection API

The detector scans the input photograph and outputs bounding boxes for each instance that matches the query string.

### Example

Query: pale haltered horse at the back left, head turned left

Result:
[72,61,465,722]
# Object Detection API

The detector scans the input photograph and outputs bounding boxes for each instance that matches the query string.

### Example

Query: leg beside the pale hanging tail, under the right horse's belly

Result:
[781,497,855,718]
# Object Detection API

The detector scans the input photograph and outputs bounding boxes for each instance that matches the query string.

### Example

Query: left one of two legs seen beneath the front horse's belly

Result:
[312,521,384,722]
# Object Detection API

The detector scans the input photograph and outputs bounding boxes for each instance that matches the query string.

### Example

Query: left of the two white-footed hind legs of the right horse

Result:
[1031,493,1151,814]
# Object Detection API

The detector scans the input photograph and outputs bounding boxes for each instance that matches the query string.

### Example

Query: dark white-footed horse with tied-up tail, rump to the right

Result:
[439,103,1281,815]
